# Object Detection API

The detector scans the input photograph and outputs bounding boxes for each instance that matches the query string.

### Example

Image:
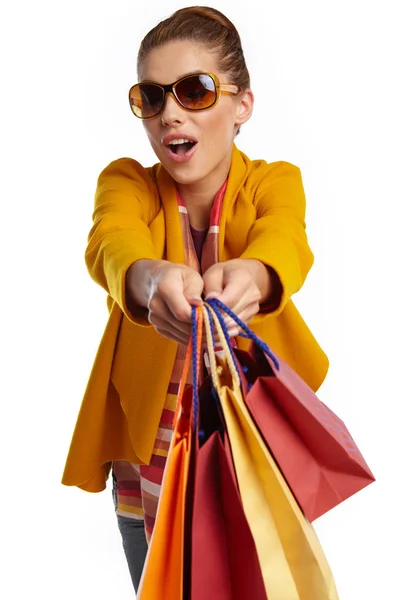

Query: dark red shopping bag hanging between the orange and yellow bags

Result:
[190,380,267,600]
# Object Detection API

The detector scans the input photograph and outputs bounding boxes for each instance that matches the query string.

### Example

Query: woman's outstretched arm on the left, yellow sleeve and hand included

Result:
[85,159,203,343]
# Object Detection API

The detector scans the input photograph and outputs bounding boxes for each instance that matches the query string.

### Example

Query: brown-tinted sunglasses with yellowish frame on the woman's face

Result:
[129,73,240,119]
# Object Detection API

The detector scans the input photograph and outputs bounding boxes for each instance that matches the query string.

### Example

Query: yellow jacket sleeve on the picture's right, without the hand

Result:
[241,161,314,318]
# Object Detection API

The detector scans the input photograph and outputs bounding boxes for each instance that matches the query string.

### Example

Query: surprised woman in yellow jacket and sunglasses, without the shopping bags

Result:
[63,7,328,589]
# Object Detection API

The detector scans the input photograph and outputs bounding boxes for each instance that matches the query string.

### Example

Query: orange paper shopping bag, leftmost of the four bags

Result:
[137,346,192,600]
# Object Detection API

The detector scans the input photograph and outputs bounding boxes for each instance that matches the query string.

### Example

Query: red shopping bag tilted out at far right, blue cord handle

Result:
[211,301,375,521]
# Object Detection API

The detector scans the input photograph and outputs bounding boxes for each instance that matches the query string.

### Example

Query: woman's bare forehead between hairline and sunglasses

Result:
[139,40,221,84]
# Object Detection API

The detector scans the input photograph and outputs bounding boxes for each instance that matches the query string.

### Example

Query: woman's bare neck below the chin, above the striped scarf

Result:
[176,157,230,229]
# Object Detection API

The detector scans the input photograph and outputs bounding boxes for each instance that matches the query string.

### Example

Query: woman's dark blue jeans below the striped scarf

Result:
[112,477,148,592]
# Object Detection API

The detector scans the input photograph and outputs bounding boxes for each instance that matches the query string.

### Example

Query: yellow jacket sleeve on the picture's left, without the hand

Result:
[85,158,157,325]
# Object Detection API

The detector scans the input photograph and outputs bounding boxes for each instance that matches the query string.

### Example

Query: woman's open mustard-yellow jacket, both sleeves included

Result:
[62,145,328,492]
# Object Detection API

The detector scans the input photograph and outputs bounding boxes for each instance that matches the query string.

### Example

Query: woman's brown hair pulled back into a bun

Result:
[137,6,250,88]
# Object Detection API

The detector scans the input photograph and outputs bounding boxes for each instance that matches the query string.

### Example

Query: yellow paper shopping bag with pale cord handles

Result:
[204,303,338,600]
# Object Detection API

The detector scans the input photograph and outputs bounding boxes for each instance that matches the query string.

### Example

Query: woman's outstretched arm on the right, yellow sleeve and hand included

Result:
[204,162,314,322]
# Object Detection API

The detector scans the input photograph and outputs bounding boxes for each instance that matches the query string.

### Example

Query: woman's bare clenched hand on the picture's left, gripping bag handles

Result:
[126,259,204,344]
